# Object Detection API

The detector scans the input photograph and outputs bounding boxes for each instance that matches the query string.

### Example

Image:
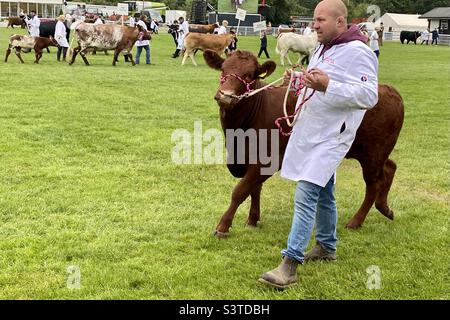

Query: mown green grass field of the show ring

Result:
[0,29,450,299]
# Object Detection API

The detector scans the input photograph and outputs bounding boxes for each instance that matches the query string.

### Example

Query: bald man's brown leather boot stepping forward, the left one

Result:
[259,257,298,290]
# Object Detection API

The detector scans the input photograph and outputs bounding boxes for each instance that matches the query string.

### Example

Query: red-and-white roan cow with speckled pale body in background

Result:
[69,22,152,66]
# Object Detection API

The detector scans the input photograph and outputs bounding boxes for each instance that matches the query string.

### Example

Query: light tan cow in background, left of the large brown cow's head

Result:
[181,32,235,66]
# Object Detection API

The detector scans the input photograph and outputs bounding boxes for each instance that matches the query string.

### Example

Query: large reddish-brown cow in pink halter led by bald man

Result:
[203,50,404,237]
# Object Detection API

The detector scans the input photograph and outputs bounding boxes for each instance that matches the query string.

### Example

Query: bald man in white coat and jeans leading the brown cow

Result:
[259,0,378,289]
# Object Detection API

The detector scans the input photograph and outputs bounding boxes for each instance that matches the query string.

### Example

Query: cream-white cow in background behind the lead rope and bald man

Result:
[275,32,317,66]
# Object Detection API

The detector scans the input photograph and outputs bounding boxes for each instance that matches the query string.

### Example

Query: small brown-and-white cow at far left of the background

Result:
[5,34,58,63]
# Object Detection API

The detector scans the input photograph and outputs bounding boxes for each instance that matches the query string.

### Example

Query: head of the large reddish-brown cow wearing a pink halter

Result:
[203,50,277,109]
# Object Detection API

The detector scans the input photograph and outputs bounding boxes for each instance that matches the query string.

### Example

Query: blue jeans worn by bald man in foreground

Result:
[281,177,337,263]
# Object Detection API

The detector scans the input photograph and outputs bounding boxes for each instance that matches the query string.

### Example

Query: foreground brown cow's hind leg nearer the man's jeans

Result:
[345,160,384,229]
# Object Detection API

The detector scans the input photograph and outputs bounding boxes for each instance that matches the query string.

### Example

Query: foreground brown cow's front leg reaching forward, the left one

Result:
[214,166,269,238]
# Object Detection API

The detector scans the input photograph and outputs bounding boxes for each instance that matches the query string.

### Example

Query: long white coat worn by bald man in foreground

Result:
[281,41,378,187]
